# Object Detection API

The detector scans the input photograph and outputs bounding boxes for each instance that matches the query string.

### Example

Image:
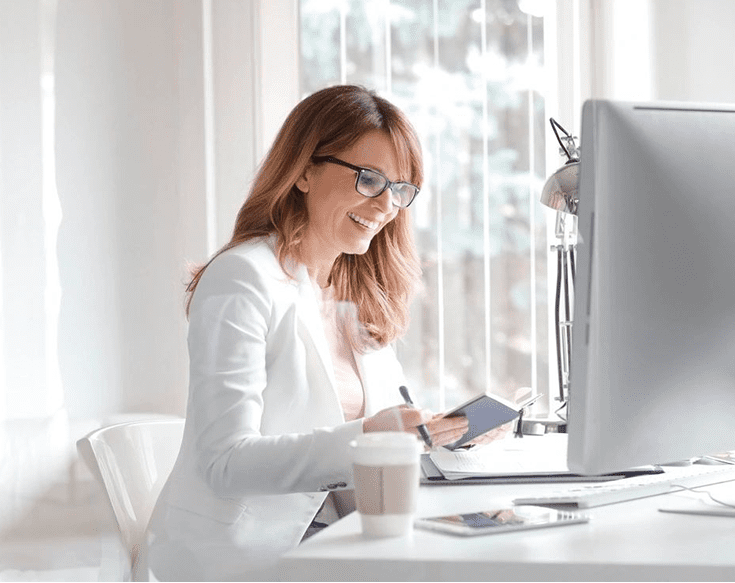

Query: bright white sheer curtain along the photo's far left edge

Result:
[0,1,63,417]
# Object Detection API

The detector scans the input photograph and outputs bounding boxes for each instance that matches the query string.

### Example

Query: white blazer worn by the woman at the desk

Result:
[148,237,403,581]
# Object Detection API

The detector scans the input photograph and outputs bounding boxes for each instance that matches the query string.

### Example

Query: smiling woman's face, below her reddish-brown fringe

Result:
[296,130,408,261]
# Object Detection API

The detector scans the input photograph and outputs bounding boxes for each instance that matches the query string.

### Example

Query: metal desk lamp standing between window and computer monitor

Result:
[541,118,579,430]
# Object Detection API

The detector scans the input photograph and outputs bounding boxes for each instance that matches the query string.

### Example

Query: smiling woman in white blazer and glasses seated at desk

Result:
[148,86,500,581]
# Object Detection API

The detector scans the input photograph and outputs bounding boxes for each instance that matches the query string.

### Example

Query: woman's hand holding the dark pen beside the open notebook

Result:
[362,405,468,445]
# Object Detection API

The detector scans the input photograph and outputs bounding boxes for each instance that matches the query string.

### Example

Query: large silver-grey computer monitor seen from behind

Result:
[567,100,735,474]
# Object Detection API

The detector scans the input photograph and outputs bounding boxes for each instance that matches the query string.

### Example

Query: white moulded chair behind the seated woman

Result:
[77,419,184,581]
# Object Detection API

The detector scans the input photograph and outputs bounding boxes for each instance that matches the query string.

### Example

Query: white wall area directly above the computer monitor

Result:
[576,0,735,104]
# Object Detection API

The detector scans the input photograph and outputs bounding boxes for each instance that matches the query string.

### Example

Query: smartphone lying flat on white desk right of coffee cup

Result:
[415,505,589,536]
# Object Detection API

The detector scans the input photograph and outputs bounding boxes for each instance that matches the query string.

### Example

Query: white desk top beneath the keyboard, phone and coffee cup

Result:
[280,482,735,581]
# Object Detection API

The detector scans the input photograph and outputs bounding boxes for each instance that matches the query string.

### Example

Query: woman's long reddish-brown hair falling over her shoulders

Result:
[186,85,423,349]
